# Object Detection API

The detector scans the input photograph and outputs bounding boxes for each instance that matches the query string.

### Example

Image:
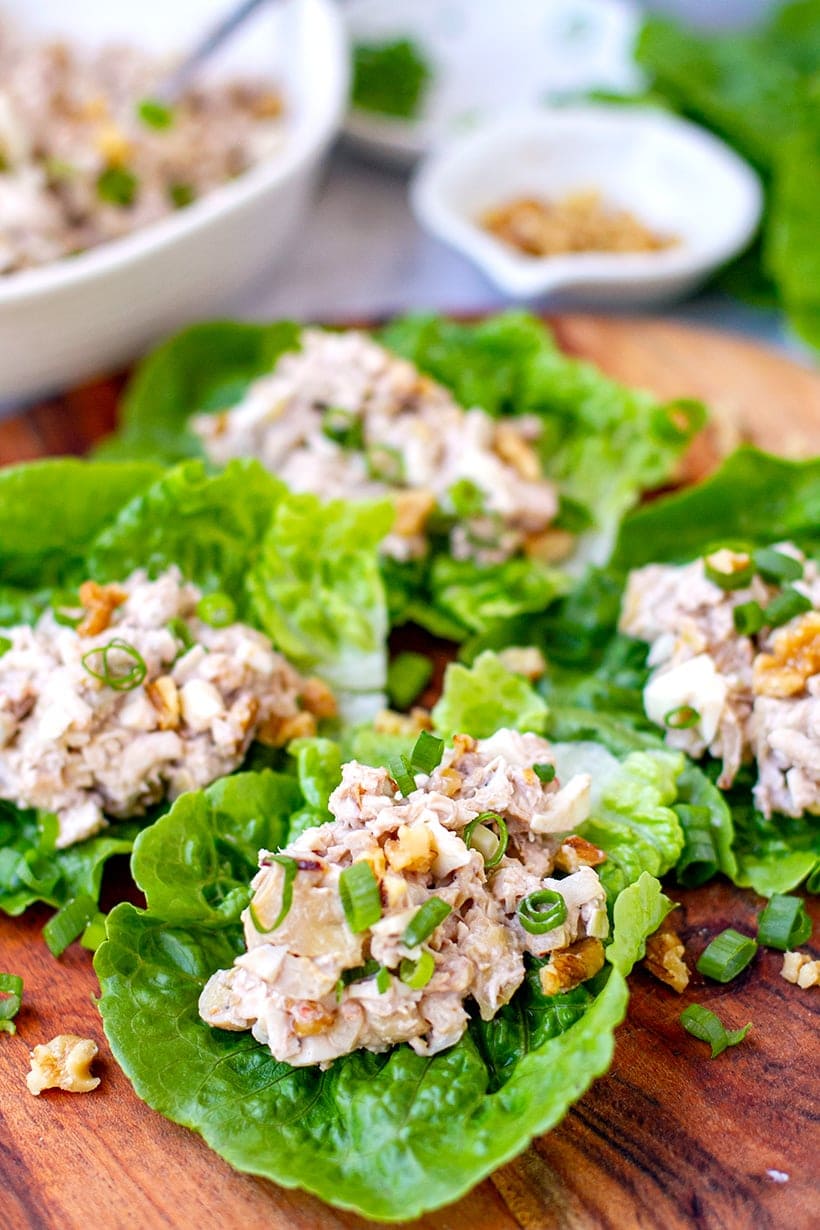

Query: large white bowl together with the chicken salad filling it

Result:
[0,0,348,405]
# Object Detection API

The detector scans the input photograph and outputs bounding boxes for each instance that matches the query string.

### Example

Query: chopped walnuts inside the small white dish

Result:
[479,192,679,256]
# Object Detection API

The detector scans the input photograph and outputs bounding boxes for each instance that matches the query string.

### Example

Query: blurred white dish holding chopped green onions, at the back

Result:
[344,0,643,167]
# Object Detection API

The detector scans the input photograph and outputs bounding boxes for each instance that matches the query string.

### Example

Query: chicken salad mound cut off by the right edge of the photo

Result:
[621,542,820,817]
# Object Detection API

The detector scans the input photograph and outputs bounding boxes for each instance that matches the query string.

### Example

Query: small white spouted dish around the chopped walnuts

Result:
[411,105,762,305]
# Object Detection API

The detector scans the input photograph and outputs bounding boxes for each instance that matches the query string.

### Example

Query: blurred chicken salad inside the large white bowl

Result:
[0,21,284,274]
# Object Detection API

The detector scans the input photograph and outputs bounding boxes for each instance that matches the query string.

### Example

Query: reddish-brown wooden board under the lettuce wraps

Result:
[0,316,820,1230]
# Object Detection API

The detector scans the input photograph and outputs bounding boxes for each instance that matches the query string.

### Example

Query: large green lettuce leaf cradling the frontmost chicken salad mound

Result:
[95,774,668,1220]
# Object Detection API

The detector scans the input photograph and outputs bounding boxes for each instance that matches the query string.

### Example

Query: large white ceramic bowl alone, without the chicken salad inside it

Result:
[0,0,348,406]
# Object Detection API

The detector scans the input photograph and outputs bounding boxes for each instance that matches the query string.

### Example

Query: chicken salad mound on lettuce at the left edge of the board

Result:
[0,568,333,847]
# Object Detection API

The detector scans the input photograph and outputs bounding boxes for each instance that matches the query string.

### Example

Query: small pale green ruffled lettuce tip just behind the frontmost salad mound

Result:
[433,651,547,739]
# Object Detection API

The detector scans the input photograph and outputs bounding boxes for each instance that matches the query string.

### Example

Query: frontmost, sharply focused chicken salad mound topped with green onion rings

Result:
[199,729,609,1066]
